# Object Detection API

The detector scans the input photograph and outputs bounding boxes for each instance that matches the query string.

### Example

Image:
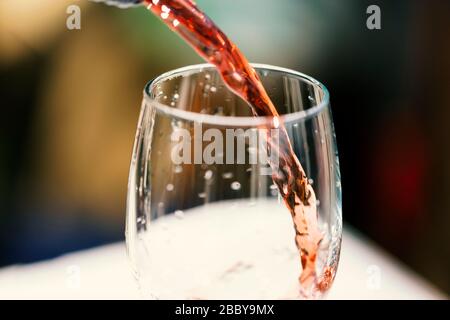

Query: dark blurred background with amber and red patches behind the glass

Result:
[0,0,450,293]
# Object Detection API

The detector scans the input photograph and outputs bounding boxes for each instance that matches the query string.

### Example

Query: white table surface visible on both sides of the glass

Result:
[0,228,442,299]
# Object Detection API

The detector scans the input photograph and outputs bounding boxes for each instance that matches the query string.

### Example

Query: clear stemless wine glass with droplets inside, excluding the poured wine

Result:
[126,64,342,299]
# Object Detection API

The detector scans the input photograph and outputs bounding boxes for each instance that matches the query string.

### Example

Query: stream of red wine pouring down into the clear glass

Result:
[143,0,335,295]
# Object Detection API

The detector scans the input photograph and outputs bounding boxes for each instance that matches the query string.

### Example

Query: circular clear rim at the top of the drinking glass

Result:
[144,63,330,127]
